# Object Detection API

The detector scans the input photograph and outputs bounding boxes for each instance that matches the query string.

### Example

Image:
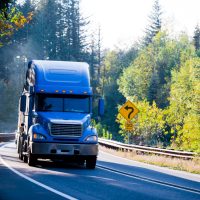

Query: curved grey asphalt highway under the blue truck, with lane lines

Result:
[0,142,200,200]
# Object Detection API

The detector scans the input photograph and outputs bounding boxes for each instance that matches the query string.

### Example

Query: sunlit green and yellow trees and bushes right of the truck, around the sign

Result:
[97,1,200,153]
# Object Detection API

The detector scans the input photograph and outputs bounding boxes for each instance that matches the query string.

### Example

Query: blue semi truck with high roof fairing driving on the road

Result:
[16,60,104,169]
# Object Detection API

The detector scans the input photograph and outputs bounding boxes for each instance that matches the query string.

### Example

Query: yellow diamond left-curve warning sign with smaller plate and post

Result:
[119,100,139,144]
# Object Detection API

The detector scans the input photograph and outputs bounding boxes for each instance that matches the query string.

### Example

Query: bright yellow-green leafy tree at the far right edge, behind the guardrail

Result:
[168,58,200,152]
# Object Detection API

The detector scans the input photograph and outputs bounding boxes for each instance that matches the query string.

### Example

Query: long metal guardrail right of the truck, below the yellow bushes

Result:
[99,138,197,159]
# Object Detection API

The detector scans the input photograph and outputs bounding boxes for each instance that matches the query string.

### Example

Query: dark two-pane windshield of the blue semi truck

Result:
[36,94,90,113]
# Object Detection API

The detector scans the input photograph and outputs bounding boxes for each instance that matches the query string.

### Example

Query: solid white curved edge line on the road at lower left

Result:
[0,156,78,200]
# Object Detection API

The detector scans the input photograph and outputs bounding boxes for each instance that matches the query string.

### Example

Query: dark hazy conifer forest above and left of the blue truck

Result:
[0,0,90,131]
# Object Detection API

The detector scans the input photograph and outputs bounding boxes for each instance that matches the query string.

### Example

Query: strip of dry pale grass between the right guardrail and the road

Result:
[99,146,200,174]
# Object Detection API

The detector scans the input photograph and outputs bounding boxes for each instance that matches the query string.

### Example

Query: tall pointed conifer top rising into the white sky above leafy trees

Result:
[144,0,162,46]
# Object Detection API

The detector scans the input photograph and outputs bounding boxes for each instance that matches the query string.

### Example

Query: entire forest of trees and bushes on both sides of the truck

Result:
[0,0,200,153]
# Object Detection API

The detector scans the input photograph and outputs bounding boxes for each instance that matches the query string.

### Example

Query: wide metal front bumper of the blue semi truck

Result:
[30,142,98,156]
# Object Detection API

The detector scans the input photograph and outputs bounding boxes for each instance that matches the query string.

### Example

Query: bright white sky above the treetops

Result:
[81,0,200,49]
